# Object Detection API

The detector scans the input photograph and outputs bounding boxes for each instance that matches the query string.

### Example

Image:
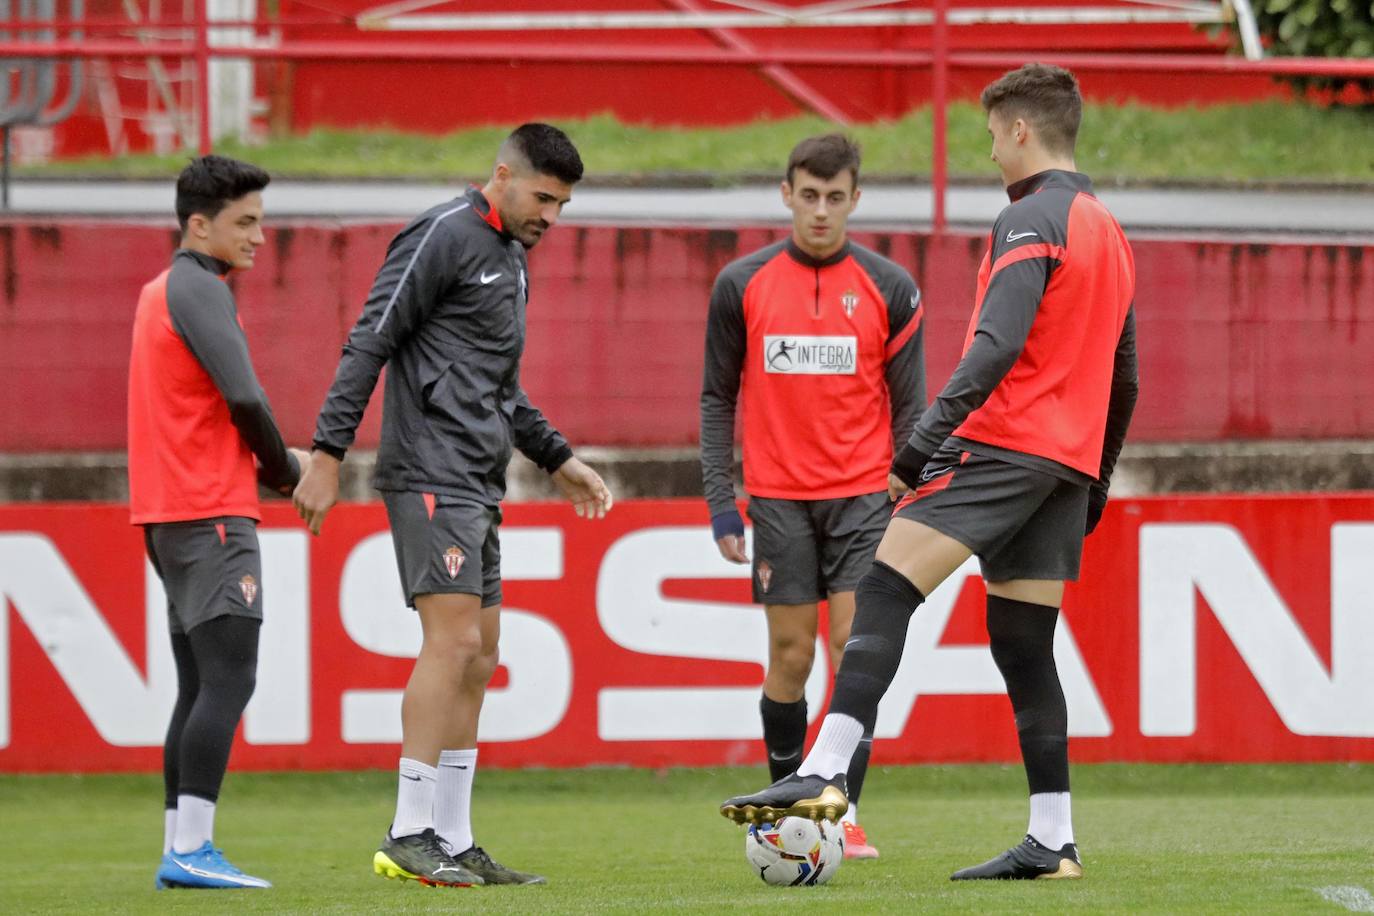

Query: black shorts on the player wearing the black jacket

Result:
[382,490,502,607]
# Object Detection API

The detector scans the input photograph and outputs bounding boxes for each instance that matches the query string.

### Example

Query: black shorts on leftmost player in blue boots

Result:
[143,515,262,633]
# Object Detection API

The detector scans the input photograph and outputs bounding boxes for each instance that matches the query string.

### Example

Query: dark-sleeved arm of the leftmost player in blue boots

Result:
[168,273,301,490]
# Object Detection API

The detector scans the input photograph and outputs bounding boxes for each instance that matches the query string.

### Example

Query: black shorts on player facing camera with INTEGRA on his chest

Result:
[749,490,892,604]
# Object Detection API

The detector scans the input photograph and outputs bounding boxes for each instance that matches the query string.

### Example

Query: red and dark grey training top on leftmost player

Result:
[129,249,301,525]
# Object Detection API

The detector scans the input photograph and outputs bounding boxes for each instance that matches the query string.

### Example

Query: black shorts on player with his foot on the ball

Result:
[893,449,1088,582]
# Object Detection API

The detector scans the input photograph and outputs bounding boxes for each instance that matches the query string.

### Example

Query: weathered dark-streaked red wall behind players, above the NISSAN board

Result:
[0,218,1374,452]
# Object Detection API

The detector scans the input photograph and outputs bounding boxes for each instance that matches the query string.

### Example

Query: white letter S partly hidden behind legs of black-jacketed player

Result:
[339,527,573,744]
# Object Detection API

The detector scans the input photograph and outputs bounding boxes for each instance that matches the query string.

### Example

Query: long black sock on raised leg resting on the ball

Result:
[830,560,926,735]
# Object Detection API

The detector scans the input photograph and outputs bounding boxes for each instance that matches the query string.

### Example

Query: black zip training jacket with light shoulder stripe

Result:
[315,188,572,505]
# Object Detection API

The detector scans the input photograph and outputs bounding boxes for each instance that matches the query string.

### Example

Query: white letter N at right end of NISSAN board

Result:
[1140,525,1374,737]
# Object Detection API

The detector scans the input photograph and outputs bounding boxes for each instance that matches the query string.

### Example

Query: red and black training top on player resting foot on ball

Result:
[911,170,1138,488]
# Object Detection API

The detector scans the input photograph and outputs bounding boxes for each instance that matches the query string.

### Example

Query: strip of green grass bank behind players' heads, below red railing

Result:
[19,102,1374,184]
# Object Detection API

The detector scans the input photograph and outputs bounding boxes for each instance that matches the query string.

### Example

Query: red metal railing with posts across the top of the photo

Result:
[0,0,1374,232]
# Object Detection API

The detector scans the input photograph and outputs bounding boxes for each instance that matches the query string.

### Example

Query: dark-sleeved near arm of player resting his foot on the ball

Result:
[893,230,1059,486]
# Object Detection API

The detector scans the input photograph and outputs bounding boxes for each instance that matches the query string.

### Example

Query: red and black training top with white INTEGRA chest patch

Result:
[701,238,926,515]
